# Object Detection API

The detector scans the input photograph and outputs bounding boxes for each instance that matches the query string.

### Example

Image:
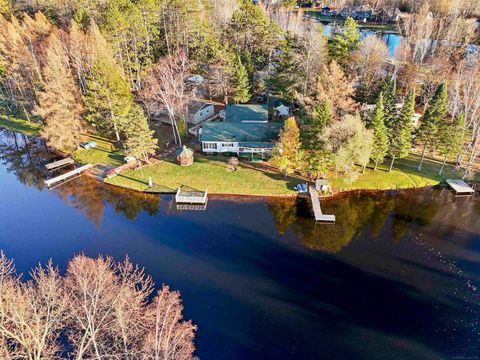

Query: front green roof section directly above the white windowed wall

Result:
[200,122,283,143]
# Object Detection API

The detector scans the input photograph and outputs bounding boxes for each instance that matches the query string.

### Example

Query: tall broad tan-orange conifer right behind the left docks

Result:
[36,34,85,151]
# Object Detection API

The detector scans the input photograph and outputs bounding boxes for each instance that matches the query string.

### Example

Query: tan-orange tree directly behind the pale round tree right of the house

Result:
[317,61,357,120]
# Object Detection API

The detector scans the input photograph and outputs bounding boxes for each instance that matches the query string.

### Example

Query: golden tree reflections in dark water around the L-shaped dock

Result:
[268,189,480,253]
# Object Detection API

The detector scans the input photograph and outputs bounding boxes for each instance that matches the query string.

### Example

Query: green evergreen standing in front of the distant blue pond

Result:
[328,17,360,66]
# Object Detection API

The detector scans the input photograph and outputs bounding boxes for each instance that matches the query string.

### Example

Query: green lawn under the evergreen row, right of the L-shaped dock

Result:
[331,155,461,190]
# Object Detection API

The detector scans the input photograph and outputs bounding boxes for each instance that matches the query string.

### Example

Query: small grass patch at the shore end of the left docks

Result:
[73,135,124,165]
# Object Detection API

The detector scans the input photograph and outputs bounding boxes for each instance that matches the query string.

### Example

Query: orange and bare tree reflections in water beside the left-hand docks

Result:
[0,130,160,226]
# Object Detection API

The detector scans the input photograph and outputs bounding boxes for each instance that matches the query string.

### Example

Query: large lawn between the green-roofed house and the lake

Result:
[108,155,302,195]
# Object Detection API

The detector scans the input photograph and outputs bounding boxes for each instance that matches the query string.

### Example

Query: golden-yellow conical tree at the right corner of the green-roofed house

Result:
[271,117,301,176]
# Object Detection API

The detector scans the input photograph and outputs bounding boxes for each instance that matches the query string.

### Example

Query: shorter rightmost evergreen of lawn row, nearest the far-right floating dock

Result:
[437,113,465,175]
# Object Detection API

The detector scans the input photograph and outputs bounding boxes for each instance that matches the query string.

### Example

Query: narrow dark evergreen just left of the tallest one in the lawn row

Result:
[388,90,415,171]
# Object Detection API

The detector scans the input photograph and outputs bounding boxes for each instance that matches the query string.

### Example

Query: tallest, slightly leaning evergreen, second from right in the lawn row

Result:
[418,82,448,171]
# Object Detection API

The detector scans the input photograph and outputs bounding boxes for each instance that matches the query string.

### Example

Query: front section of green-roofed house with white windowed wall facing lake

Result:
[200,122,283,158]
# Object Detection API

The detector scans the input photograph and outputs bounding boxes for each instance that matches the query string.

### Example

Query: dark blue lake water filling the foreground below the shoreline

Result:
[0,130,480,360]
